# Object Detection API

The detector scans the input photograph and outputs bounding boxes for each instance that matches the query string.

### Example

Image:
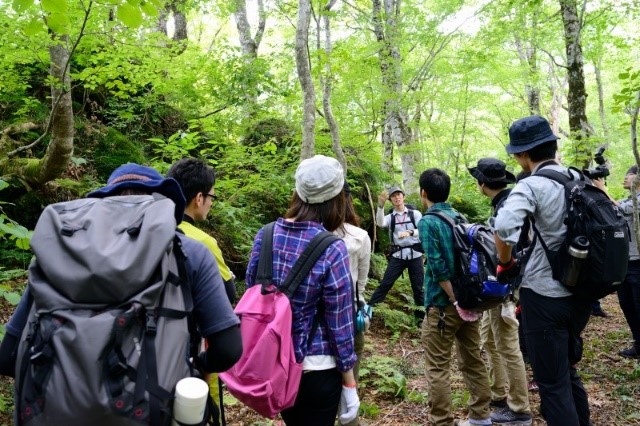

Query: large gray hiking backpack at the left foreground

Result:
[15,194,205,426]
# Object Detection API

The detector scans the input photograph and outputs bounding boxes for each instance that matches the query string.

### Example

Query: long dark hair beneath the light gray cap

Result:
[284,191,346,232]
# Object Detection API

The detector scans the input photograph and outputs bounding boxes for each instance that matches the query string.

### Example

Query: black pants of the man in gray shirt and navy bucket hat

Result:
[520,288,591,426]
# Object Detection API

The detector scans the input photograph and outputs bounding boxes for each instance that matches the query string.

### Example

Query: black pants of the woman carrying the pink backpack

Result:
[281,368,342,426]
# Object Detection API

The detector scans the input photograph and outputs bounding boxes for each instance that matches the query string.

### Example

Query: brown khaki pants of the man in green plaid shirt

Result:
[422,305,491,426]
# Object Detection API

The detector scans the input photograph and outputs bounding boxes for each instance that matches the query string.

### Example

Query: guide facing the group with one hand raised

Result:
[369,186,424,323]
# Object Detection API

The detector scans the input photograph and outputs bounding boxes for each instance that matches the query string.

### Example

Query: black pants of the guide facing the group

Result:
[369,256,424,318]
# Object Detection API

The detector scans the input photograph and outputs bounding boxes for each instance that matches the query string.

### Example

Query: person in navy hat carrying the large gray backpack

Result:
[0,163,242,426]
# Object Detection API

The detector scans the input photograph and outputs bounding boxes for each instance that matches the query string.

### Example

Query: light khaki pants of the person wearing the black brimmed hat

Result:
[480,302,531,414]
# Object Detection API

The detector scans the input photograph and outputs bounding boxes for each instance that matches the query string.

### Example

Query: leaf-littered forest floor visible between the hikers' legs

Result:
[0,289,640,426]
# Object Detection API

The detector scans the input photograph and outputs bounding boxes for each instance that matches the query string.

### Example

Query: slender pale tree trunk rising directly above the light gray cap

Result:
[295,0,316,160]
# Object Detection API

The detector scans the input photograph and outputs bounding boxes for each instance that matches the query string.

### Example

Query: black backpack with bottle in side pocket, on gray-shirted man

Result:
[533,165,630,300]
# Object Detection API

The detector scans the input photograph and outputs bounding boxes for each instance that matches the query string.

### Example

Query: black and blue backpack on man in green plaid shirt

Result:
[427,211,510,311]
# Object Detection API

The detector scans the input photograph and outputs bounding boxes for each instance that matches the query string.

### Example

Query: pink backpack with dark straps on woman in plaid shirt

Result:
[220,222,338,419]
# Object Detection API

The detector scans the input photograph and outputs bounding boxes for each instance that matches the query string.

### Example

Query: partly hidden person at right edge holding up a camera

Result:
[592,165,640,359]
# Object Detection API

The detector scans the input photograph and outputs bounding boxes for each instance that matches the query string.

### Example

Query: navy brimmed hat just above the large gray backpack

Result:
[87,163,186,223]
